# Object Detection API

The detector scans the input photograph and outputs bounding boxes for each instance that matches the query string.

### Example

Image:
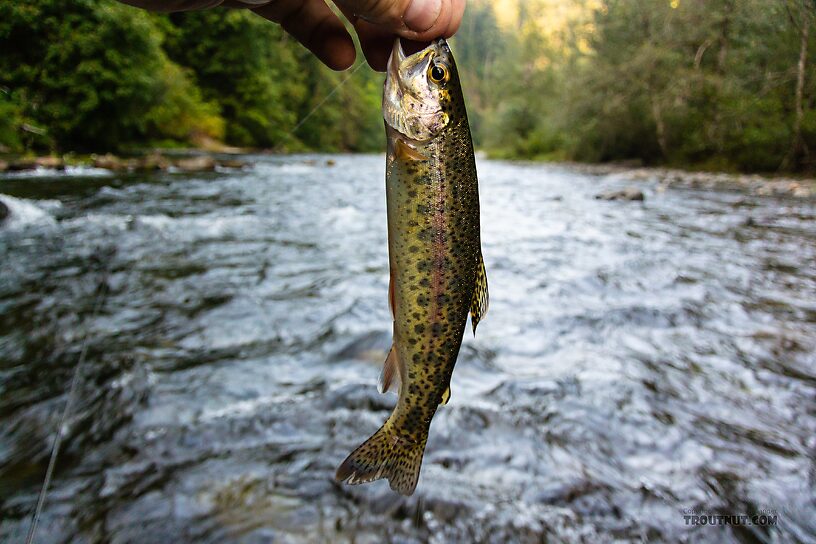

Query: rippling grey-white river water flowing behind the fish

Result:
[0,156,816,543]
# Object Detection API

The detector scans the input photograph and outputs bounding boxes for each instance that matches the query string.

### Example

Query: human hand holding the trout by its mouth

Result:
[247,0,465,71]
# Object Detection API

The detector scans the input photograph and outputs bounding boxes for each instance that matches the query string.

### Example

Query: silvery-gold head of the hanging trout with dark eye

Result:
[383,38,459,142]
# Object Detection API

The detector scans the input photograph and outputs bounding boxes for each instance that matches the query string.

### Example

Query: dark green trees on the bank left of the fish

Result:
[0,0,382,151]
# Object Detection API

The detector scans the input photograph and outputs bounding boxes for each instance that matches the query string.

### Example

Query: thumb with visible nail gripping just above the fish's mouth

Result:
[335,0,451,34]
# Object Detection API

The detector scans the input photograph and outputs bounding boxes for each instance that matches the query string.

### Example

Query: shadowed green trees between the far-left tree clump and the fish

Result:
[160,10,382,151]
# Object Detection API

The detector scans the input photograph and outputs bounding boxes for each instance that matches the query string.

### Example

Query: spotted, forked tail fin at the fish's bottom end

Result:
[335,422,425,495]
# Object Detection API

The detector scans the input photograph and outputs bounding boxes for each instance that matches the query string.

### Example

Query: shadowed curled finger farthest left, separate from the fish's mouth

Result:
[252,0,356,70]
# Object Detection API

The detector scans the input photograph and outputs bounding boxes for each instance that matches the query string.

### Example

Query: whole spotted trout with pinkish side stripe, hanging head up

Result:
[335,38,489,496]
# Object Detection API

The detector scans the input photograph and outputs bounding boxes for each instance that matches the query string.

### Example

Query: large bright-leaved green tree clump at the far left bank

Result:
[0,0,223,150]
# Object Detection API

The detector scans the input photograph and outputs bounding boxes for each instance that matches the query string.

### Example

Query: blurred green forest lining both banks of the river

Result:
[0,0,816,172]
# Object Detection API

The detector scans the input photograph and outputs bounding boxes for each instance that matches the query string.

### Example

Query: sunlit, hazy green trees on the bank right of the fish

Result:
[456,0,816,171]
